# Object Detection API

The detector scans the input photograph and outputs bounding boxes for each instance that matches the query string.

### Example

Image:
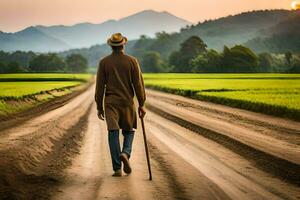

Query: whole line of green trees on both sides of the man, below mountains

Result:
[0,32,300,73]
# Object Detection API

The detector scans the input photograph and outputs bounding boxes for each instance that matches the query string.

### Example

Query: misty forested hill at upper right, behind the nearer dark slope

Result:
[181,10,297,50]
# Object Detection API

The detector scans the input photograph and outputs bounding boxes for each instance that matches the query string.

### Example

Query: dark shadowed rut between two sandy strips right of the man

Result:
[147,104,300,186]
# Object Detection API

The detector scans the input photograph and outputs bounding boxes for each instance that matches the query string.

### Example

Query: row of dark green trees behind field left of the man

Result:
[0,51,88,73]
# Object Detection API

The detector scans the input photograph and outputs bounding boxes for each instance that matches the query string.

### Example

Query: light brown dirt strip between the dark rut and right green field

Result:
[147,91,300,164]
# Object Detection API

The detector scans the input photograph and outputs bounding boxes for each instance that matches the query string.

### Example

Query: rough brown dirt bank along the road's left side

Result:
[0,85,91,199]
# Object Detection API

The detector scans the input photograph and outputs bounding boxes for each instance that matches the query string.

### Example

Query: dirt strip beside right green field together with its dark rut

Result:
[147,90,300,185]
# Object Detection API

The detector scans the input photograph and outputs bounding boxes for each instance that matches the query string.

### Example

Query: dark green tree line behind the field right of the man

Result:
[135,36,300,73]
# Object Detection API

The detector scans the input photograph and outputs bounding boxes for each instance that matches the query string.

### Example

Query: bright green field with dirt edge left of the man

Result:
[0,74,91,116]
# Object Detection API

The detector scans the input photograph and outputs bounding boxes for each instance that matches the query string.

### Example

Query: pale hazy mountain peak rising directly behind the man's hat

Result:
[37,10,190,48]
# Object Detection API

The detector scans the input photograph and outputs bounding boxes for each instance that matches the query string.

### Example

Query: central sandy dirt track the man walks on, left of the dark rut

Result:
[53,88,300,199]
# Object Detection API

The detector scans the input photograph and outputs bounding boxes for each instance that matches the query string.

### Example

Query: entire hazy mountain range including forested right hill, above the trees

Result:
[0,10,300,66]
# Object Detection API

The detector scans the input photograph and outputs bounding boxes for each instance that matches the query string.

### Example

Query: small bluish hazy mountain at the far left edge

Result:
[0,27,70,51]
